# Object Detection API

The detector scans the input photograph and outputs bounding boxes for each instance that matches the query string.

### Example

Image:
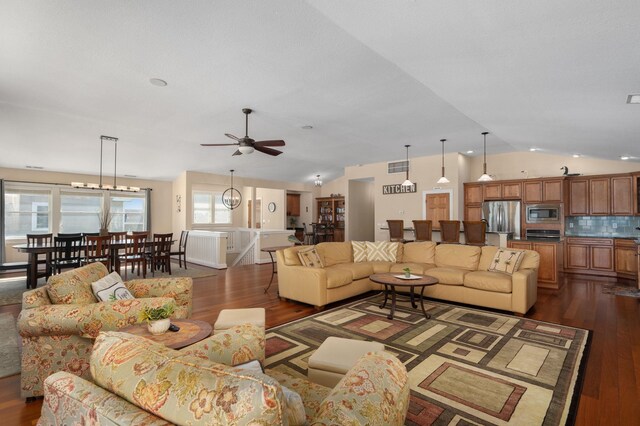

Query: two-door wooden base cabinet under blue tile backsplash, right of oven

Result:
[565,237,615,276]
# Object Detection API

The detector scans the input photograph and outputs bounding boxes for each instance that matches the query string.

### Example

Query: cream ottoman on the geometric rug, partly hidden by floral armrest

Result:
[307,337,384,388]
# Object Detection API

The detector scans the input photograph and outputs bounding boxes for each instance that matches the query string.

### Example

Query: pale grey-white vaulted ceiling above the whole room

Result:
[0,0,640,182]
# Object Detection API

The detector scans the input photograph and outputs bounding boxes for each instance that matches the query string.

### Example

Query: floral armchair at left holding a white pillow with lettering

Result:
[17,262,193,398]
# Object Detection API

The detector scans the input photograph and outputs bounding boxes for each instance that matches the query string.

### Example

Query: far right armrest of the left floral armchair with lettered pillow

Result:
[124,277,193,318]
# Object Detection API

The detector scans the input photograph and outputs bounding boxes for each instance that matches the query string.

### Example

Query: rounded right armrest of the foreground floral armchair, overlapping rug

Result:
[311,352,409,425]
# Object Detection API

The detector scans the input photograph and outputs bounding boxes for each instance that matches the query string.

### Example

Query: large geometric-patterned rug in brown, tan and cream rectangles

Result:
[265,295,590,425]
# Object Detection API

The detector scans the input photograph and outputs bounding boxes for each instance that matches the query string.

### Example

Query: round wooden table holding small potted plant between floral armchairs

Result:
[118,320,213,349]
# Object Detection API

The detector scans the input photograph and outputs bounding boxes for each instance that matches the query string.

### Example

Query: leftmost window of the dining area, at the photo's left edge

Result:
[4,185,51,238]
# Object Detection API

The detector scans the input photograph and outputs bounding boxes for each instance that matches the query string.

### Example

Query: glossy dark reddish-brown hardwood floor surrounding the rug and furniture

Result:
[0,265,640,425]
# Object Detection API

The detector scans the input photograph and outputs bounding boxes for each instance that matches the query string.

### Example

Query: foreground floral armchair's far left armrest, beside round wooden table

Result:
[180,324,265,366]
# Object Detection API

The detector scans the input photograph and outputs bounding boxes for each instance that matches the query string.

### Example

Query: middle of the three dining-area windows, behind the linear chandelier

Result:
[60,191,102,233]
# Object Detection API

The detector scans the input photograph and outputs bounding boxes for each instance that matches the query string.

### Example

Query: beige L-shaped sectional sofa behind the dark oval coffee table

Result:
[277,241,540,314]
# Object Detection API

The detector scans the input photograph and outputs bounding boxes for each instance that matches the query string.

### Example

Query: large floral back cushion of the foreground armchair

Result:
[90,332,286,424]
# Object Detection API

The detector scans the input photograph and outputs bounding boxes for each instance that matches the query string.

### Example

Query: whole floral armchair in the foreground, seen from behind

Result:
[38,324,409,426]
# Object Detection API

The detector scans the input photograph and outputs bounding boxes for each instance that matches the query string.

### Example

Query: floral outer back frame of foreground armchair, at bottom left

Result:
[38,371,171,426]
